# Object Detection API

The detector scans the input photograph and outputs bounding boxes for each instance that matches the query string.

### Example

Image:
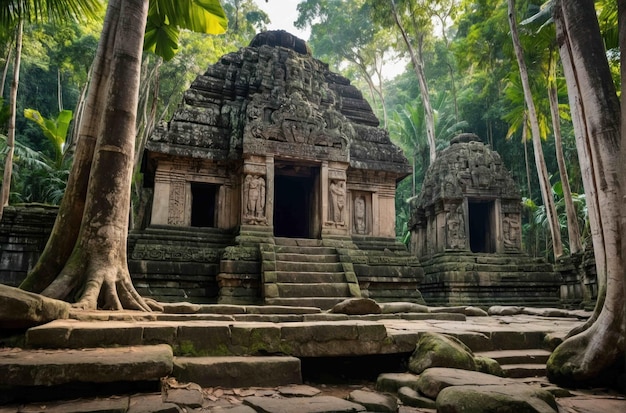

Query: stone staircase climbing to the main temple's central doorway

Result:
[260,238,361,309]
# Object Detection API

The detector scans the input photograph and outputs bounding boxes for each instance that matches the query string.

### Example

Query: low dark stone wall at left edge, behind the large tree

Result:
[0,204,57,287]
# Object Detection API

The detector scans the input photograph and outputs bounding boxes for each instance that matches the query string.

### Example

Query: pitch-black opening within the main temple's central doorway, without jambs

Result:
[274,168,315,238]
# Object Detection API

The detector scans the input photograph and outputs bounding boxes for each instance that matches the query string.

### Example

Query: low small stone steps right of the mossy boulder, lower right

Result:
[476,348,550,379]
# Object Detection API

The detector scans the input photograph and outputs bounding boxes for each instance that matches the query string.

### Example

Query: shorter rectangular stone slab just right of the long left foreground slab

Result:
[173,357,302,387]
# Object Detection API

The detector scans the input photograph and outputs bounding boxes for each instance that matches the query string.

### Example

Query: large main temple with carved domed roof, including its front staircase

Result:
[134,31,421,307]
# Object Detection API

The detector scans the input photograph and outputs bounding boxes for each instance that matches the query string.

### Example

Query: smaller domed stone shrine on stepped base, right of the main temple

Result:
[409,133,561,306]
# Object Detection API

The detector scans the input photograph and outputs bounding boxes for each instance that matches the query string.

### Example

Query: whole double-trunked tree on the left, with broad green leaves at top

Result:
[21,0,227,310]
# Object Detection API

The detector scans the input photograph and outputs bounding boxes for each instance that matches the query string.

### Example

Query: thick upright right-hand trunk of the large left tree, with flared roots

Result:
[23,0,150,310]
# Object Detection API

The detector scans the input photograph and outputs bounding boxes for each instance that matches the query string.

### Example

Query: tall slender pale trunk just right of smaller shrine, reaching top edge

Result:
[508,0,563,258]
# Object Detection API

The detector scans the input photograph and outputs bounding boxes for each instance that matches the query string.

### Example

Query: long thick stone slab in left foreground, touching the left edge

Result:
[0,345,173,386]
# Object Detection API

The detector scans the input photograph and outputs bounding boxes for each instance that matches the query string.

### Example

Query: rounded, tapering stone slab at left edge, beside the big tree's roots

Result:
[0,284,71,328]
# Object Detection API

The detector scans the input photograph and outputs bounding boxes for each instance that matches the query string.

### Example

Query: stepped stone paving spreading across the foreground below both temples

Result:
[0,304,626,413]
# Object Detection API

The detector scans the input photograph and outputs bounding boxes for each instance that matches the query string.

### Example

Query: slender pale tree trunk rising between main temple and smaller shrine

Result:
[391,0,437,164]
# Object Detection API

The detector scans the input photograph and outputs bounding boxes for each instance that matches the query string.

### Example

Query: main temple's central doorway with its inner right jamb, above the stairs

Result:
[274,163,319,238]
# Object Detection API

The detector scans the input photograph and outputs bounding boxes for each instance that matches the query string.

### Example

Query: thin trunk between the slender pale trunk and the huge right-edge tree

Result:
[548,50,583,254]
